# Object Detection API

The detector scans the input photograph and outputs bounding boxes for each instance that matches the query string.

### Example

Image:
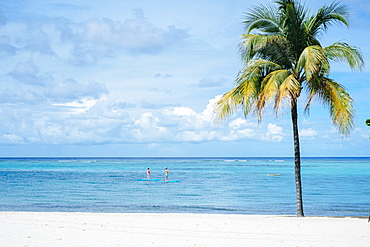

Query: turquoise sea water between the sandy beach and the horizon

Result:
[0,158,370,216]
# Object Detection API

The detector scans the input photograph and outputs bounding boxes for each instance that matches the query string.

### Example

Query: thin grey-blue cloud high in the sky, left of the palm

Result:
[58,8,189,65]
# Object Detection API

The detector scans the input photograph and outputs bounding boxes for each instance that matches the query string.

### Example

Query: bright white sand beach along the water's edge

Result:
[0,212,370,247]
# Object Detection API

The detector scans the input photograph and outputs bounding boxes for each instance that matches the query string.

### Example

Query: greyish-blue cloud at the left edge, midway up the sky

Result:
[0,60,108,106]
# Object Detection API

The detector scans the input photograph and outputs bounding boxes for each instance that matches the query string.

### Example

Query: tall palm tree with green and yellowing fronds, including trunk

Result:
[214,0,364,217]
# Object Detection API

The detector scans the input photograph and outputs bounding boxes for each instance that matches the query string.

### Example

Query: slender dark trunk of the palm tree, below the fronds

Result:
[291,99,304,217]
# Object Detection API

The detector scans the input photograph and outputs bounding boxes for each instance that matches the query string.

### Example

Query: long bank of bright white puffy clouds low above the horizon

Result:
[0,93,264,144]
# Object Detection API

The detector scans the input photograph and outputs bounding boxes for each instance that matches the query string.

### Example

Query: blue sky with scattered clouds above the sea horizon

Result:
[0,0,370,157]
